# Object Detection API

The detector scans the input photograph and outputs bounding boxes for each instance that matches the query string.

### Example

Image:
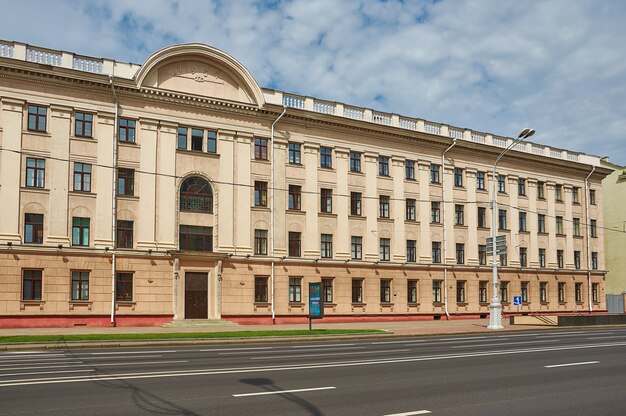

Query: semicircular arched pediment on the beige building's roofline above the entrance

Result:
[135,43,265,107]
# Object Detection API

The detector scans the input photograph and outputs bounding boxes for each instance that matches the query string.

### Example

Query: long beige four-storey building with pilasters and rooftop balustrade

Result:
[0,41,609,327]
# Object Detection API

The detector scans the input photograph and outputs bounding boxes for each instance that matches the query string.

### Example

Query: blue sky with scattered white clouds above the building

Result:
[0,0,626,165]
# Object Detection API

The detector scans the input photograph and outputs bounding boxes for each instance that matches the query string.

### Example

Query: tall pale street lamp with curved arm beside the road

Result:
[487,127,535,329]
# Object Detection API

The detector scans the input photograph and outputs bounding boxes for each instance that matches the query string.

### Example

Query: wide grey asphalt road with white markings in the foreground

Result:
[0,329,626,416]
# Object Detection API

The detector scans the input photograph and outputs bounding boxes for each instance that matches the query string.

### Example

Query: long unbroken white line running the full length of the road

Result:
[0,342,626,387]
